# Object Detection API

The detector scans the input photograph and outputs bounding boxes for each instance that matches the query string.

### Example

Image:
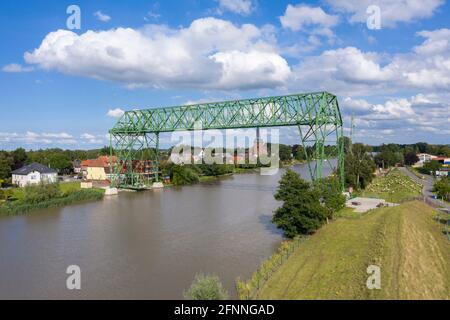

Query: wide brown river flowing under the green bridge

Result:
[0,165,334,299]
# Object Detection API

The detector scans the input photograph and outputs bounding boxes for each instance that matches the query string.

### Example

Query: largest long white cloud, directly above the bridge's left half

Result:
[25,18,291,89]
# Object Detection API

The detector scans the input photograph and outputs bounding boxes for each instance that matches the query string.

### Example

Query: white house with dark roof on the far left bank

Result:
[12,163,58,187]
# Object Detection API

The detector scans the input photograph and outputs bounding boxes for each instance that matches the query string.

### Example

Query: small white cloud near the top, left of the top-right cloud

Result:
[280,4,339,32]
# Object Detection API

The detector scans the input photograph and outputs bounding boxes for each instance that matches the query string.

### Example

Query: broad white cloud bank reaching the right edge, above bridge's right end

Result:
[293,29,450,96]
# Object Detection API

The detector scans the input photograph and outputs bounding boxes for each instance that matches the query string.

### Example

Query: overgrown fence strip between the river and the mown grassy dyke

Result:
[236,236,308,300]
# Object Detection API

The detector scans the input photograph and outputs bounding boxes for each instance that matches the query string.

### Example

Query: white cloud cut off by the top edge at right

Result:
[326,0,444,28]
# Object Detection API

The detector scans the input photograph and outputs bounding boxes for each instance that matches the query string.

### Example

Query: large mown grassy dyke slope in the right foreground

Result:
[258,201,450,299]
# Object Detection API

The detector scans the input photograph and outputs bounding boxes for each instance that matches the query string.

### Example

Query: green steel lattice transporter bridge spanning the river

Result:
[109,92,344,189]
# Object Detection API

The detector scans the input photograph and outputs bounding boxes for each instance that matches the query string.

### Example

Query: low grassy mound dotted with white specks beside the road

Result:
[361,169,422,202]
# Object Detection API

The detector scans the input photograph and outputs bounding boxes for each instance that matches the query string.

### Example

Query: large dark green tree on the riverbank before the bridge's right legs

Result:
[272,170,327,238]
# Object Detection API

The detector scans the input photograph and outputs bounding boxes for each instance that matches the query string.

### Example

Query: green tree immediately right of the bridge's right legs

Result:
[344,143,376,189]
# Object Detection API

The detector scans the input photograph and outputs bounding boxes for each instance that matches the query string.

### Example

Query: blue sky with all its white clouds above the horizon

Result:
[0,0,450,150]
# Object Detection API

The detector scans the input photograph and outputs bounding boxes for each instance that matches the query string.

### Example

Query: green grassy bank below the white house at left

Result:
[0,182,104,215]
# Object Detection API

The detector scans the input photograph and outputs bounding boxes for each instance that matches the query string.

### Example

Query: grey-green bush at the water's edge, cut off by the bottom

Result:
[183,274,228,300]
